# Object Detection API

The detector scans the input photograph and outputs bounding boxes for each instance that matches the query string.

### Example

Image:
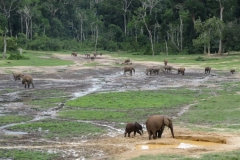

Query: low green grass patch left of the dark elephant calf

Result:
[8,119,104,139]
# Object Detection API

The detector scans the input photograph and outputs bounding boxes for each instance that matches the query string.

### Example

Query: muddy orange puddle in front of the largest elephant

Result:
[135,139,222,150]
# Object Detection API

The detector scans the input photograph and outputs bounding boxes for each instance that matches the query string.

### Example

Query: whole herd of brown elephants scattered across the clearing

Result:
[10,52,235,140]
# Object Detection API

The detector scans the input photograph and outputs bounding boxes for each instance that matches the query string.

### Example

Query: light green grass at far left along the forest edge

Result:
[0,51,74,67]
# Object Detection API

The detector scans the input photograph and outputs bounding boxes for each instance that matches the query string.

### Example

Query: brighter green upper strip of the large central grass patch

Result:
[66,89,208,109]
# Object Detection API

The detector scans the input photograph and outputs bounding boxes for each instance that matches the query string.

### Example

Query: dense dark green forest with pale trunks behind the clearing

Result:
[0,0,240,57]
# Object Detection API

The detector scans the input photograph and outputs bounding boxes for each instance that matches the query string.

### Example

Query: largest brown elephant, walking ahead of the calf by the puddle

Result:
[146,115,174,140]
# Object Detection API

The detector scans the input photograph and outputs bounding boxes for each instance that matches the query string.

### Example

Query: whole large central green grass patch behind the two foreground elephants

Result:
[58,88,213,123]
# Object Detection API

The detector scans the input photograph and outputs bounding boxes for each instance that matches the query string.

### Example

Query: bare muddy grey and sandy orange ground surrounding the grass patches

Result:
[0,54,240,160]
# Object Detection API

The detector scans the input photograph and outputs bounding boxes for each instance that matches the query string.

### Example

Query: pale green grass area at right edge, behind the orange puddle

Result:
[179,94,240,129]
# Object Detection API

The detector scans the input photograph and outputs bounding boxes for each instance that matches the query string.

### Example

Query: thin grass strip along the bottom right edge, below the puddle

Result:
[132,151,240,160]
